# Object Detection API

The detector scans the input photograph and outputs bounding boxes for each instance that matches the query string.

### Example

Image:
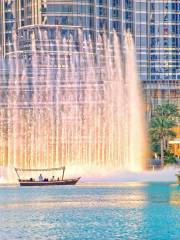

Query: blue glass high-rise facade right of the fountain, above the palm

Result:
[134,0,180,113]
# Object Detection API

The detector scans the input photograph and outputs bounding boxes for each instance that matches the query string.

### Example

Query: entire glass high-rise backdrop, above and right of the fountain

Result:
[0,0,180,111]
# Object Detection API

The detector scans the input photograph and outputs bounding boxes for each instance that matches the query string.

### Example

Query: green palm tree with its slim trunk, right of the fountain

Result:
[150,103,179,165]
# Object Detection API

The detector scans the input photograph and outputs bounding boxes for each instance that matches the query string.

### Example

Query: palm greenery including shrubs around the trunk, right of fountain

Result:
[149,103,180,166]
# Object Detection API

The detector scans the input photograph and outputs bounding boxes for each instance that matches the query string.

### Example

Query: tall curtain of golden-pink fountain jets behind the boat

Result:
[0,30,147,180]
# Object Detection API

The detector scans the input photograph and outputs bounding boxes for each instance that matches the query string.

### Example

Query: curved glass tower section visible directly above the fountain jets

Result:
[1,0,129,54]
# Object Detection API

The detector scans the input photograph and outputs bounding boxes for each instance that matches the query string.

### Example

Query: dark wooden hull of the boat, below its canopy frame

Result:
[19,178,80,187]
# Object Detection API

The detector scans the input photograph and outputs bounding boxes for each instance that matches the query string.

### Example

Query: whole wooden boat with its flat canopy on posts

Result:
[15,167,80,187]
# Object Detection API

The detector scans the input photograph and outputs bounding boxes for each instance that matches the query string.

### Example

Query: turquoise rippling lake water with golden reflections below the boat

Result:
[0,183,180,240]
